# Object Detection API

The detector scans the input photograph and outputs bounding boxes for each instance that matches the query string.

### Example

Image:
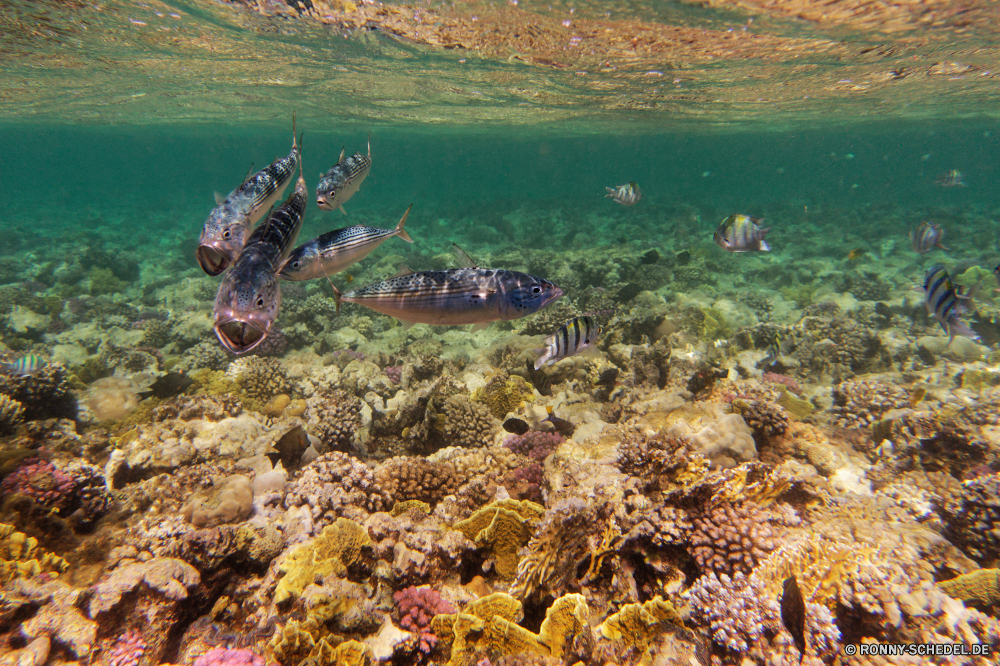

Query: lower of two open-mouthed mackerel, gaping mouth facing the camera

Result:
[213,154,309,354]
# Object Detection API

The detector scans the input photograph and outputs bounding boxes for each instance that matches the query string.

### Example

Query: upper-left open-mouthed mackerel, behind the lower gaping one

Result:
[196,114,300,276]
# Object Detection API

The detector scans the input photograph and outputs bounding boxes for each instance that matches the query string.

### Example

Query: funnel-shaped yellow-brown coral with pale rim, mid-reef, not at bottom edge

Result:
[455,499,545,578]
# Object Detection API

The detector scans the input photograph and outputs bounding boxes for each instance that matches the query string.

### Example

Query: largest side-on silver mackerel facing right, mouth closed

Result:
[334,268,563,331]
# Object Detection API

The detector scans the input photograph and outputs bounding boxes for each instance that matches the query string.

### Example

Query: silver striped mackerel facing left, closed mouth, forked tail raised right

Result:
[278,204,413,281]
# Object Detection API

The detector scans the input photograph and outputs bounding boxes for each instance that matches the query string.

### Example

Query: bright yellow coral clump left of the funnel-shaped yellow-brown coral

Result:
[274,518,372,603]
